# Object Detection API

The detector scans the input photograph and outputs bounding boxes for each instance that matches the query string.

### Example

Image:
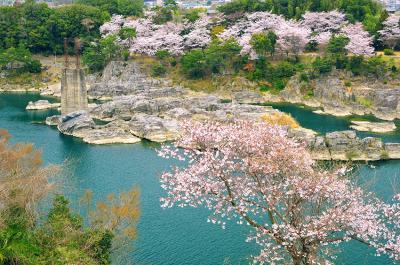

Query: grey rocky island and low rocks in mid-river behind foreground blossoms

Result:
[30,61,400,161]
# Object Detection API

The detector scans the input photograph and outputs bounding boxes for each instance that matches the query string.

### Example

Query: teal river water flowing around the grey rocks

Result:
[0,94,400,265]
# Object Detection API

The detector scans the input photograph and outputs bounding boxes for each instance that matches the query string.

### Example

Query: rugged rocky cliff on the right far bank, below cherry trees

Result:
[281,73,400,120]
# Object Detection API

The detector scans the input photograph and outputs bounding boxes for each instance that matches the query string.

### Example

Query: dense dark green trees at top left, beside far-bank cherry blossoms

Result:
[0,0,144,54]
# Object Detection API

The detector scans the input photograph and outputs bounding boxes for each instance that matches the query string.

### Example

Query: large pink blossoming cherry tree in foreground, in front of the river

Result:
[160,121,400,265]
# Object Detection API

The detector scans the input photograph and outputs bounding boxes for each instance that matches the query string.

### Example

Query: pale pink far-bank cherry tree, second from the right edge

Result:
[341,23,375,56]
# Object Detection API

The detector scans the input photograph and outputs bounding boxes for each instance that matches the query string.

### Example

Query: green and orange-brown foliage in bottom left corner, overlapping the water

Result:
[0,130,140,265]
